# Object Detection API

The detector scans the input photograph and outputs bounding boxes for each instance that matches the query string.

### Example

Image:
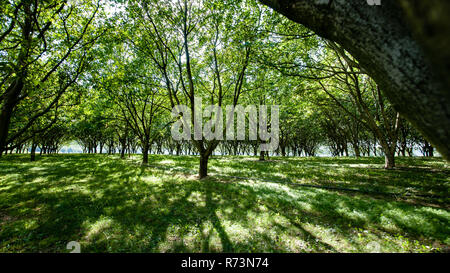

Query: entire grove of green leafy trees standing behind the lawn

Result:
[0,0,440,178]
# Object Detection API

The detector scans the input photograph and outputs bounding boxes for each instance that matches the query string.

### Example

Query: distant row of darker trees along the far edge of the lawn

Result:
[5,108,434,160]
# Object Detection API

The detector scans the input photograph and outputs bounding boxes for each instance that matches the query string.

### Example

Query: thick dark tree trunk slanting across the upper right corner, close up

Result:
[260,0,450,160]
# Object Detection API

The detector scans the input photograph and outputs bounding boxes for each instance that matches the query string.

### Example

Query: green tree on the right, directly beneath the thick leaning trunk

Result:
[318,44,401,169]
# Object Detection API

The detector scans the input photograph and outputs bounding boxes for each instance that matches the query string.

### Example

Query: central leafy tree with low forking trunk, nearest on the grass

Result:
[129,0,259,178]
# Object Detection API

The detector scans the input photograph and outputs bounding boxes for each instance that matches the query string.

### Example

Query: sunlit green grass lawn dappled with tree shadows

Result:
[0,155,450,252]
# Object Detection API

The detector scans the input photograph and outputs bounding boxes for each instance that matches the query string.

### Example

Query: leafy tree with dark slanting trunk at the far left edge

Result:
[0,0,106,156]
